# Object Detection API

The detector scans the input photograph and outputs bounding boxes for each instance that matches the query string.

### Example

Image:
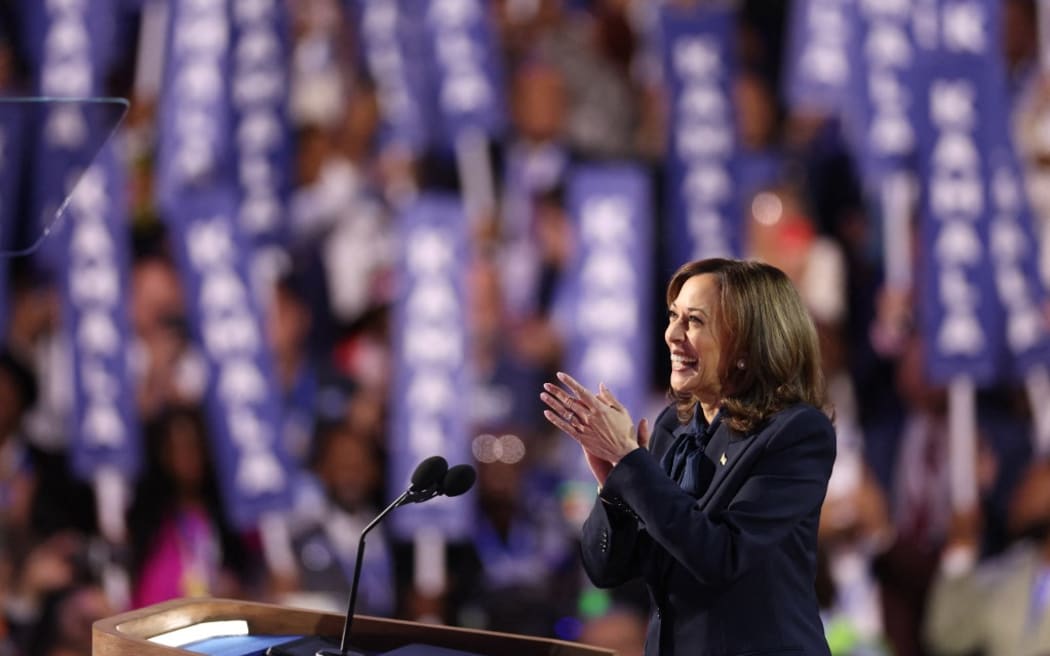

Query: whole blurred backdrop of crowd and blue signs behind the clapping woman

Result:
[0,0,1050,656]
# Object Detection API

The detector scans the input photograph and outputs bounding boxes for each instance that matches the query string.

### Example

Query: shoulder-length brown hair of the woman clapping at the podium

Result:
[667,258,828,432]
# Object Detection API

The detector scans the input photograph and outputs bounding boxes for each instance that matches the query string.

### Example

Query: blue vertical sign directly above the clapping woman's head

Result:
[660,4,744,274]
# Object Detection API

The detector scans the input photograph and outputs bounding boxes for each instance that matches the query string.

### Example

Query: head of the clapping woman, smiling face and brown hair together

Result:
[664,259,826,432]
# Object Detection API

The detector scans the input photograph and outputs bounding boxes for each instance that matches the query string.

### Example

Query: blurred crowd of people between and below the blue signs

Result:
[0,0,1050,656]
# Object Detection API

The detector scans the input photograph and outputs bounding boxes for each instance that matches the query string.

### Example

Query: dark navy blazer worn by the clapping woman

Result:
[582,404,835,656]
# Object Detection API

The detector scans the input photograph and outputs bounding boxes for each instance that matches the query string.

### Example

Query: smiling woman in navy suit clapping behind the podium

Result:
[541,259,835,656]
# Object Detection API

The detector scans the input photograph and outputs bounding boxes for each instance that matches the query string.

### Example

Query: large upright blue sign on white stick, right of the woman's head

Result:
[914,0,1002,384]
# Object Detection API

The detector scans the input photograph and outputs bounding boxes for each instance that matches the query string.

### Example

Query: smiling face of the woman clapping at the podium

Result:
[664,273,721,404]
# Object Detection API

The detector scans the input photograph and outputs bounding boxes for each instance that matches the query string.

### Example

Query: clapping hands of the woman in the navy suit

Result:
[540,372,648,466]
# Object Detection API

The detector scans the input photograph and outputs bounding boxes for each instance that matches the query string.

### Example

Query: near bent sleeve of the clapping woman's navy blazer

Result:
[604,406,835,586]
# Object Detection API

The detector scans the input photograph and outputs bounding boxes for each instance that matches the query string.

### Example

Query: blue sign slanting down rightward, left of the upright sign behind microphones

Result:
[164,188,291,527]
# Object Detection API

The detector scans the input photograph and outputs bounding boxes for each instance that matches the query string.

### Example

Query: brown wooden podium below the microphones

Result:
[91,597,615,656]
